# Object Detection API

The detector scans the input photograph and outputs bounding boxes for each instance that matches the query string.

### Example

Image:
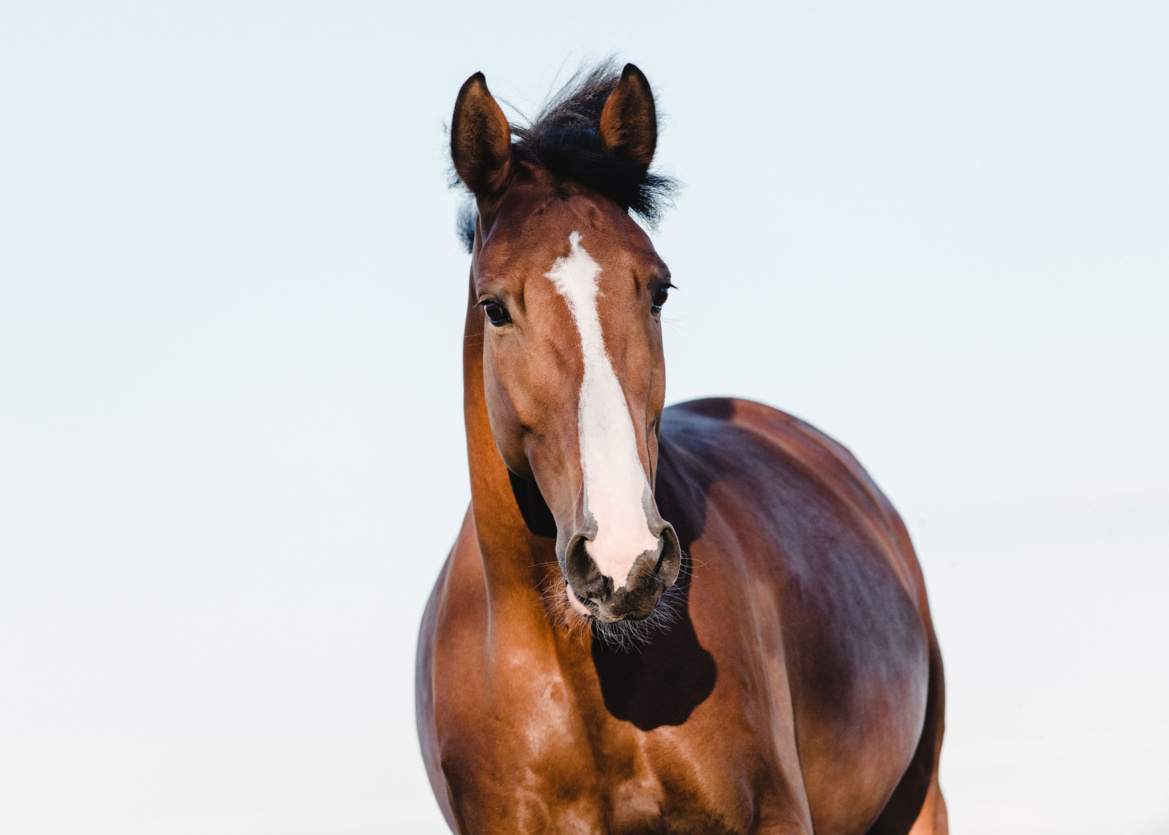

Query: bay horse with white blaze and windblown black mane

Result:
[416,64,947,835]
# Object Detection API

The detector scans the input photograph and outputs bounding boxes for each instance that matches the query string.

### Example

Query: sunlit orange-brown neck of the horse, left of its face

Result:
[463,288,556,612]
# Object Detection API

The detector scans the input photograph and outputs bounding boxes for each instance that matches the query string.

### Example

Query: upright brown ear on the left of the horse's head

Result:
[450,73,511,198]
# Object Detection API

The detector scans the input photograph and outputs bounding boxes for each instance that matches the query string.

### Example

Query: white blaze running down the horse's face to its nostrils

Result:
[545,232,658,588]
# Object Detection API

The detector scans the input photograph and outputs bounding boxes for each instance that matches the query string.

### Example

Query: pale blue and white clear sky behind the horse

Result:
[0,0,1169,835]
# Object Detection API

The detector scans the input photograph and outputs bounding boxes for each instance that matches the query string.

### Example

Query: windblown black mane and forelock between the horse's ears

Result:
[458,61,677,251]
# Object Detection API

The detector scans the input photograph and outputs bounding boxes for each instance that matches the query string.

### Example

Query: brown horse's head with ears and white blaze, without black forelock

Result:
[451,68,680,622]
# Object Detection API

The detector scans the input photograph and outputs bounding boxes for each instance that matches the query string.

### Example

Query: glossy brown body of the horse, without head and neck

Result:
[419,392,941,835]
